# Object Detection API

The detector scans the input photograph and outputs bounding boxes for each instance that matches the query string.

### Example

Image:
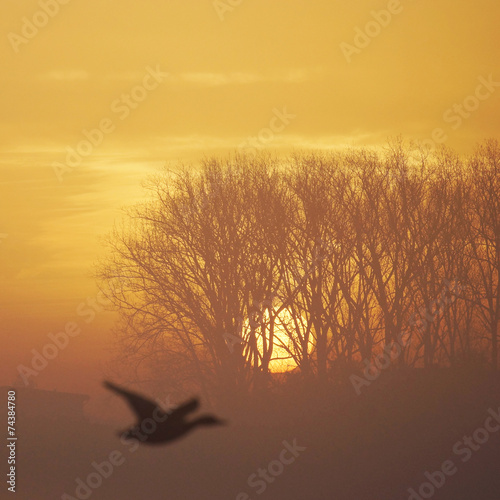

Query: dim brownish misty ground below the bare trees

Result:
[2,369,500,500]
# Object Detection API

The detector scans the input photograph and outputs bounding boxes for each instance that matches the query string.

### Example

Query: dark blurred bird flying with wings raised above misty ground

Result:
[104,381,224,445]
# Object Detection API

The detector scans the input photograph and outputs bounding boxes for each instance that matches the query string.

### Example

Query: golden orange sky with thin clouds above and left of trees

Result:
[0,0,500,391]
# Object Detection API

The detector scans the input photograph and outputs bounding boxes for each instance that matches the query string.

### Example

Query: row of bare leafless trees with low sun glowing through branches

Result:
[99,140,500,394]
